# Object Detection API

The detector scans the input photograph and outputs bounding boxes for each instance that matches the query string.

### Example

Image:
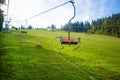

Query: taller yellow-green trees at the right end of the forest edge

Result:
[91,13,120,37]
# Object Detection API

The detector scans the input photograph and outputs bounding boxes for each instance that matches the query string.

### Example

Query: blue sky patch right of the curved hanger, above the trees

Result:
[76,0,120,21]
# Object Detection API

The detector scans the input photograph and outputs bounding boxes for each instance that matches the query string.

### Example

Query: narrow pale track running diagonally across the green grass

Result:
[54,48,95,80]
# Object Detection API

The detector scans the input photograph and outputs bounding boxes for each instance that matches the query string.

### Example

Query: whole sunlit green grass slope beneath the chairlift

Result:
[0,30,120,80]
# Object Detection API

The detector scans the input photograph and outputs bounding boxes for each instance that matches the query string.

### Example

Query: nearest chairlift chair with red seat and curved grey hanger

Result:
[60,0,80,50]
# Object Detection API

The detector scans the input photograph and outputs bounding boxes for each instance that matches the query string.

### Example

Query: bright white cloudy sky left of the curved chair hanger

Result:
[4,0,72,27]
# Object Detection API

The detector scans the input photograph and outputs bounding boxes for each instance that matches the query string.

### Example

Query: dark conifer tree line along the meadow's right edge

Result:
[61,13,120,37]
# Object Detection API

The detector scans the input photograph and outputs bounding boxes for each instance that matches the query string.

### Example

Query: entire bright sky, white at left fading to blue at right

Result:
[2,0,120,28]
